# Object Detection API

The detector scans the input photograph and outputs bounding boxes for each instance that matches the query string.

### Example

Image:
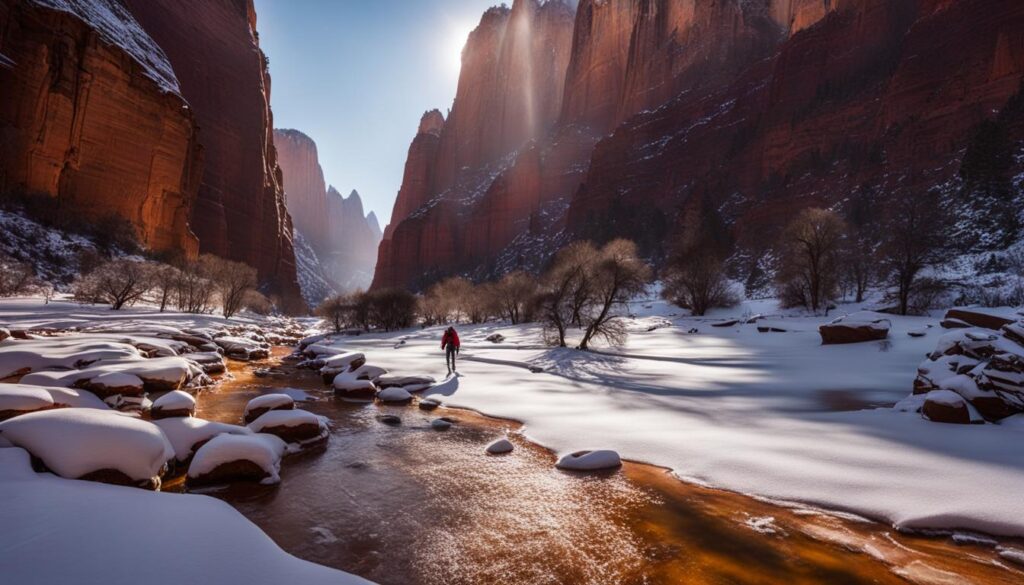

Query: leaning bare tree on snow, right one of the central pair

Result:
[580,240,651,349]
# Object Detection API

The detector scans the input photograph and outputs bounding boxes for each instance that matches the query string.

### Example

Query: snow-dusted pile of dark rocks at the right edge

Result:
[897,309,1024,424]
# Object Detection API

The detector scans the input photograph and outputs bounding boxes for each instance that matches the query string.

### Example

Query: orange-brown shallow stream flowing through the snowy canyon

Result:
[190,351,1024,584]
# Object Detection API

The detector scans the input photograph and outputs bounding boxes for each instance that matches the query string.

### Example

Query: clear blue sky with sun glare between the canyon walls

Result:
[255,0,501,226]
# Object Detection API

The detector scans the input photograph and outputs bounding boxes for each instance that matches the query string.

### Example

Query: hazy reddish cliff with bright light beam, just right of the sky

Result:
[374,0,590,287]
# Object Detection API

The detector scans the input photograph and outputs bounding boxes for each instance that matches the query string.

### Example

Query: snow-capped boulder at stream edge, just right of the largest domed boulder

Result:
[187,433,286,486]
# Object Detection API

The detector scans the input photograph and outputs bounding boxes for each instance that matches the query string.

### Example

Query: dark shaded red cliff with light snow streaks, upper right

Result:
[568,0,1024,251]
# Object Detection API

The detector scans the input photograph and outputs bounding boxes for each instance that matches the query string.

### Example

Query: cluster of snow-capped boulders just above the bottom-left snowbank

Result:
[0,384,329,490]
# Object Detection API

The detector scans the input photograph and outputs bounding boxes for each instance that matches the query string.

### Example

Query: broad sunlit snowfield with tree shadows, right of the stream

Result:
[307,301,1024,536]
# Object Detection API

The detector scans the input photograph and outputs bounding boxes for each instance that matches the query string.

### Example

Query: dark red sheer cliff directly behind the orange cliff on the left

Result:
[122,0,300,308]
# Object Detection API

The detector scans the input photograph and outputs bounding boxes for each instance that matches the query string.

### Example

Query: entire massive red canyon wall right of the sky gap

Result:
[375,0,1024,287]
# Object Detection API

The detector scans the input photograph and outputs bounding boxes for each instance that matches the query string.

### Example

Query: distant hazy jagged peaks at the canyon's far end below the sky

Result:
[274,129,381,297]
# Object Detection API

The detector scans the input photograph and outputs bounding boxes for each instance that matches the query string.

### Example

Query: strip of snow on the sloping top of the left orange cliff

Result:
[32,0,181,95]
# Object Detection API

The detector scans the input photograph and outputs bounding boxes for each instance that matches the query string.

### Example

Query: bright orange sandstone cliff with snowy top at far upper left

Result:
[0,0,202,257]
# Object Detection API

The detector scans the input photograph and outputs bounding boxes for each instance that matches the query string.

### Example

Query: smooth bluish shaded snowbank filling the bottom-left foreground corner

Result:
[0,449,368,585]
